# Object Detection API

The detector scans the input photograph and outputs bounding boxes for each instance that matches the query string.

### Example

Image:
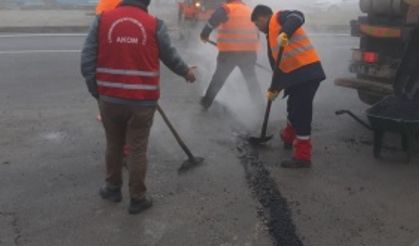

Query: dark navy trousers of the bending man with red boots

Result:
[285,81,320,137]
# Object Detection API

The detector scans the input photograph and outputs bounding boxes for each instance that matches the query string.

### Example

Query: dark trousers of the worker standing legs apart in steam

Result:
[203,52,264,105]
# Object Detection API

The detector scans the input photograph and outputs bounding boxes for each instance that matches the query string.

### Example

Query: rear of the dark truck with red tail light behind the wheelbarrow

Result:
[335,0,419,105]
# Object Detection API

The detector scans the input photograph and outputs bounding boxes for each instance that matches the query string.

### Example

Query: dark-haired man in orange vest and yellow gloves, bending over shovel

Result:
[251,5,326,168]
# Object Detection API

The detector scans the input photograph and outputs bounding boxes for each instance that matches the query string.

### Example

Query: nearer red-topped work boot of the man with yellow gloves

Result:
[281,137,312,168]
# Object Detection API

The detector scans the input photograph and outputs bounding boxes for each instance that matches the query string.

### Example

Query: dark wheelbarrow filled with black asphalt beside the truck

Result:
[336,96,419,162]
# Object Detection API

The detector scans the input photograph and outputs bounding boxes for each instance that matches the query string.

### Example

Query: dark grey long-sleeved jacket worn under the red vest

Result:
[81,0,188,105]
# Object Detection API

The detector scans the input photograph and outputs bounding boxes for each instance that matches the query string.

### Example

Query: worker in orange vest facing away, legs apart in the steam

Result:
[201,0,263,109]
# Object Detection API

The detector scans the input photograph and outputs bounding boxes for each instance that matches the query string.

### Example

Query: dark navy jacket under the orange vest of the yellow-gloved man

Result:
[266,10,326,90]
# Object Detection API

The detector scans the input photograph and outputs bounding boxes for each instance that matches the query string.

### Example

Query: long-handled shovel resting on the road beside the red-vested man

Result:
[157,105,204,174]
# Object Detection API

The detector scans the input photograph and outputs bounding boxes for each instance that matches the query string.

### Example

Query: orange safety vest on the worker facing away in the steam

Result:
[217,2,260,52]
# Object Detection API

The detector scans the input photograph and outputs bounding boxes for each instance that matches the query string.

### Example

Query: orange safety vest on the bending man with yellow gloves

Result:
[269,12,320,73]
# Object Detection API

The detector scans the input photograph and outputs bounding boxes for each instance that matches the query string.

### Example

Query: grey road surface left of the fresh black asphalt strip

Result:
[0,33,272,246]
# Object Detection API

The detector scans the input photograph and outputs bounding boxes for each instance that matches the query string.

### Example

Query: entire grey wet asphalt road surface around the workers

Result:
[0,34,419,246]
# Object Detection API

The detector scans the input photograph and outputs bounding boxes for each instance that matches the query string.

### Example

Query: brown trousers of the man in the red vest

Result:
[99,100,156,200]
